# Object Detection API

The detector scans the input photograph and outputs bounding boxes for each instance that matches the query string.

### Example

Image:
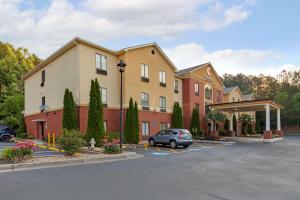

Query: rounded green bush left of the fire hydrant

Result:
[57,130,85,156]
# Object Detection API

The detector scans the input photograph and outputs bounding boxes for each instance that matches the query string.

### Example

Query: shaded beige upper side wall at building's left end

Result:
[25,46,78,115]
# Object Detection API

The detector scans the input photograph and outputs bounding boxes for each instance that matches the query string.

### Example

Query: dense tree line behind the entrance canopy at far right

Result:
[221,70,300,128]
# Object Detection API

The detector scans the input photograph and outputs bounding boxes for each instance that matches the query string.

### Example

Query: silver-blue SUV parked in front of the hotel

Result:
[149,129,193,149]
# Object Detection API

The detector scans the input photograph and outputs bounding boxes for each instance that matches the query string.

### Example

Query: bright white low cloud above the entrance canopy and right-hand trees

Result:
[164,43,300,75]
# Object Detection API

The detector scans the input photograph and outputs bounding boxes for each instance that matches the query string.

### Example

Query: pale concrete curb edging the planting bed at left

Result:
[0,152,143,172]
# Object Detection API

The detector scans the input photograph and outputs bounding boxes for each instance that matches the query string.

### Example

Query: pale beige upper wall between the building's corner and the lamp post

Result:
[79,44,120,107]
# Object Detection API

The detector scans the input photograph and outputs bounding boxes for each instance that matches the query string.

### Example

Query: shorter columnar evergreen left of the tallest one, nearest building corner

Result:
[63,89,78,130]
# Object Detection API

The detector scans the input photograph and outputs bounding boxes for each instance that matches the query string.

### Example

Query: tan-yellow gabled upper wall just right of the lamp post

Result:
[125,46,175,112]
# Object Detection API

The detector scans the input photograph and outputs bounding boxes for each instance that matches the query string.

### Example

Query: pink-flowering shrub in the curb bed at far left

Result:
[1,141,36,162]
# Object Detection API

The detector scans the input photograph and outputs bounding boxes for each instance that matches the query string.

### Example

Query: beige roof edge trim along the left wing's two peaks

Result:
[22,37,177,80]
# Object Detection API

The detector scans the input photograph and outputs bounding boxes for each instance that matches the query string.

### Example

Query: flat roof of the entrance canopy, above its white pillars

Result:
[210,99,283,113]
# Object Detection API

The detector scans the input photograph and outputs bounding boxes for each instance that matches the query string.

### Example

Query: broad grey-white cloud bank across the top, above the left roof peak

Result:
[0,0,251,57]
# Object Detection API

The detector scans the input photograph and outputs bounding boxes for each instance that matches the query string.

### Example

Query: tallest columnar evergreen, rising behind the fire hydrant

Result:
[87,79,105,145]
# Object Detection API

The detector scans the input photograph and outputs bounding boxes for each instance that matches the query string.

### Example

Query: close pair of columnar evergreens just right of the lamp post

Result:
[125,98,139,144]
